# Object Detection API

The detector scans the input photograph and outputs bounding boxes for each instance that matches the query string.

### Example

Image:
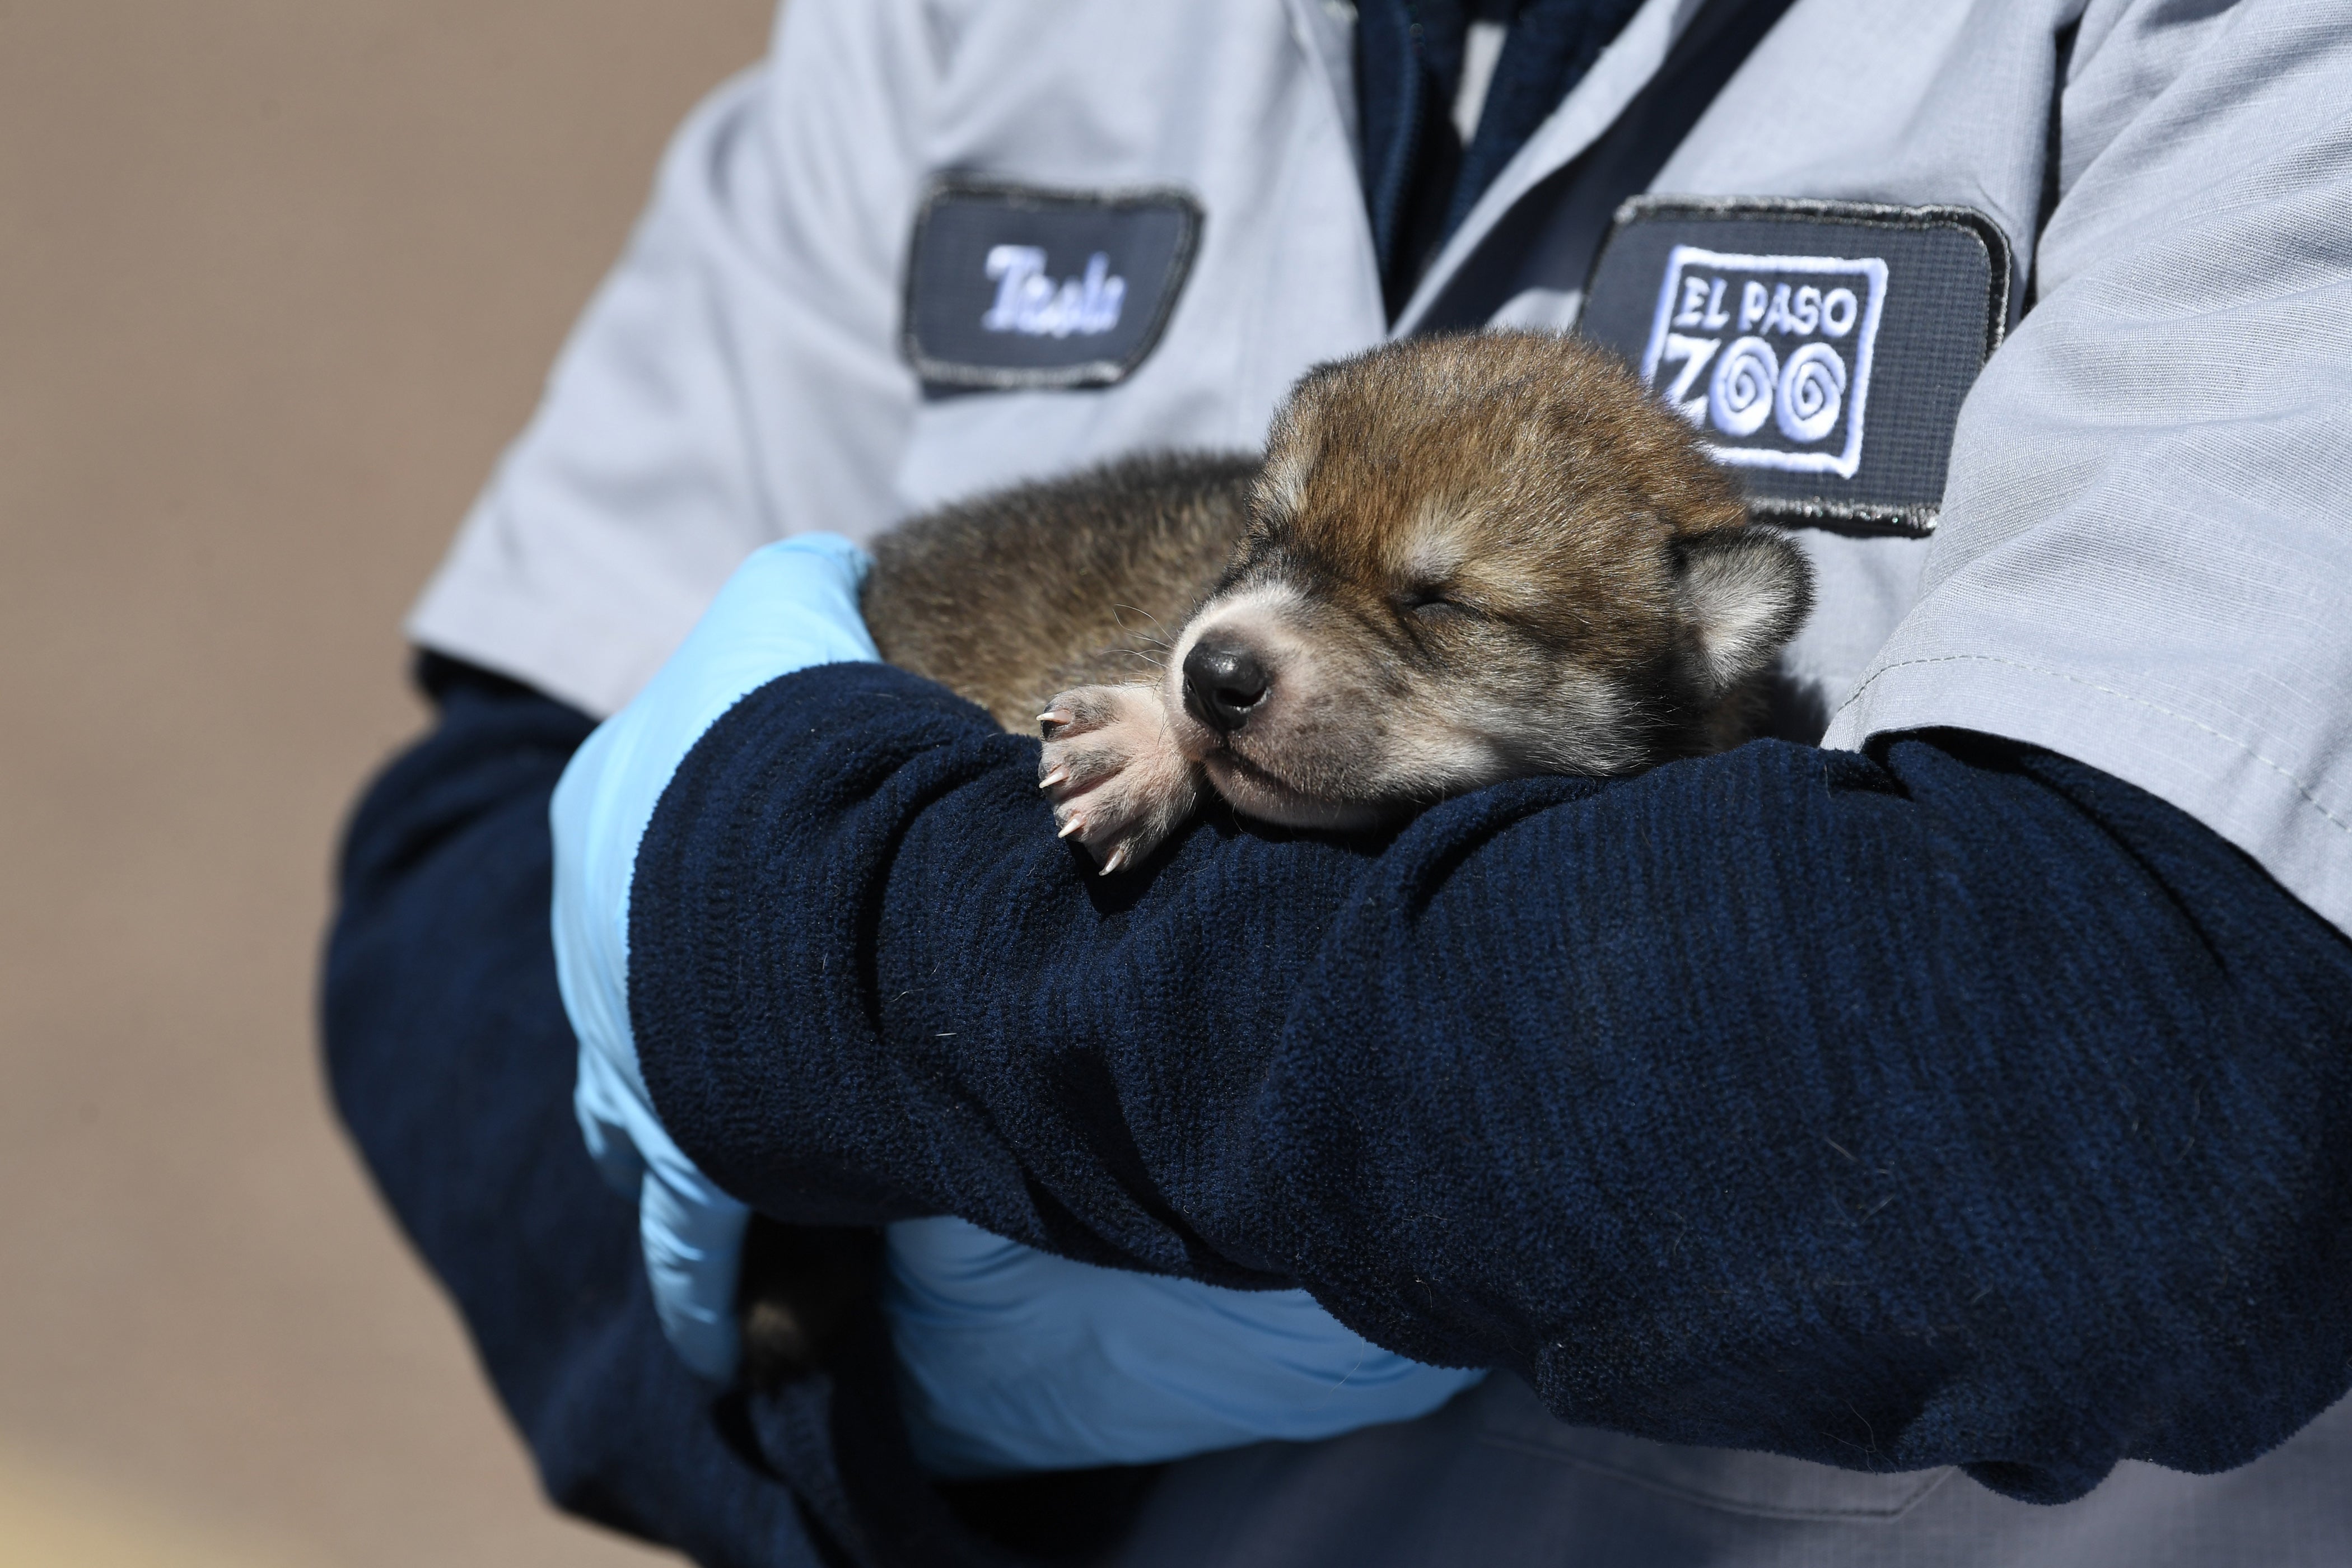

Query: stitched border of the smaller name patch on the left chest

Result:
[898,174,1204,390]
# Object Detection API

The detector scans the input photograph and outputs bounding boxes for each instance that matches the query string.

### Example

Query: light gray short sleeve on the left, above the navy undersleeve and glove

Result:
[409,0,931,717]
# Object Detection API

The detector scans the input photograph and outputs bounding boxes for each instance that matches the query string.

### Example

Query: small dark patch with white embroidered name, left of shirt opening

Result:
[906,179,1200,388]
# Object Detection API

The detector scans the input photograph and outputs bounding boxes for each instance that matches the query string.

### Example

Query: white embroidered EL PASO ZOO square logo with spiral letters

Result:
[1642,245,1886,479]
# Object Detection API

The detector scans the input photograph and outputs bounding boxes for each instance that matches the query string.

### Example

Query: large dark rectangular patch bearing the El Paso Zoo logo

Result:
[1578,198,2009,534]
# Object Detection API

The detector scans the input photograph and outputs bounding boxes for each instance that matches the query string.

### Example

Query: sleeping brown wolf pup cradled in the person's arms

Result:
[866,334,1811,872]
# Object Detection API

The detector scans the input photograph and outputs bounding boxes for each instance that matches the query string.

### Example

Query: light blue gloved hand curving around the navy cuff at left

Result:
[548,534,880,1382]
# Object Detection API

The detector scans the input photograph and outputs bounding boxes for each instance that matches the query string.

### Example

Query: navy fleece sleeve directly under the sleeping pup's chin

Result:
[631,668,2352,1500]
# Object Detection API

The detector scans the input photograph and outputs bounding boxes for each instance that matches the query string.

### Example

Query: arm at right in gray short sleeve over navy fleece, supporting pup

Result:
[633,0,2352,1495]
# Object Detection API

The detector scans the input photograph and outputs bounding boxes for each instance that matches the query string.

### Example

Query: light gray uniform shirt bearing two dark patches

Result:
[409,0,2352,1564]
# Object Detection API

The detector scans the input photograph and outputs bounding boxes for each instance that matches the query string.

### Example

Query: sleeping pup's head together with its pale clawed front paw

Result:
[1011,334,1811,872]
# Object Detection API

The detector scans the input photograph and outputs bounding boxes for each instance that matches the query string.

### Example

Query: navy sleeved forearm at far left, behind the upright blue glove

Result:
[320,656,1081,1568]
